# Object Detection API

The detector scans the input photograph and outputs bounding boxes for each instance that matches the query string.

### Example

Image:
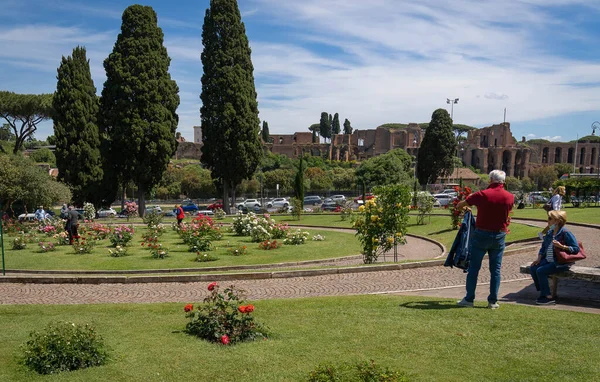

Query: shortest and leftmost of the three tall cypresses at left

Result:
[52,46,103,207]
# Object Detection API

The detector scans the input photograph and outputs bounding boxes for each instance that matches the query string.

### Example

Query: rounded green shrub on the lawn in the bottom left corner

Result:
[22,322,107,374]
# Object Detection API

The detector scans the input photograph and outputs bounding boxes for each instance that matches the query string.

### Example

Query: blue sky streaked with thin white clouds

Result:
[0,0,600,141]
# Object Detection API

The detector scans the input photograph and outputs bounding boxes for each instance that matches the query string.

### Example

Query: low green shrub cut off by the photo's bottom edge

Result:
[308,360,408,382]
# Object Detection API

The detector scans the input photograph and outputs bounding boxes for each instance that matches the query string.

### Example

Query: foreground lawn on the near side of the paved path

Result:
[0,295,600,382]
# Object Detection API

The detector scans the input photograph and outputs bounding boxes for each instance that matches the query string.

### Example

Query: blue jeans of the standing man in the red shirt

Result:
[465,229,506,304]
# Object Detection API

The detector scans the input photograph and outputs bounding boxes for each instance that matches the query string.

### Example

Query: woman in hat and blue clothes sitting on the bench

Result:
[530,211,579,305]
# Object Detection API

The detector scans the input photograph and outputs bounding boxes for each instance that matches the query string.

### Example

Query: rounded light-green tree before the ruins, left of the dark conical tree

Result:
[356,149,412,188]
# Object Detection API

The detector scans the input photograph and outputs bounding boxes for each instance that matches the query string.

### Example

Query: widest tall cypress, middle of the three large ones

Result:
[100,5,179,215]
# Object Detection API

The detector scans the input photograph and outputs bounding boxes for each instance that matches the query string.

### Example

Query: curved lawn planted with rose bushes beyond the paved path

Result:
[5,226,360,270]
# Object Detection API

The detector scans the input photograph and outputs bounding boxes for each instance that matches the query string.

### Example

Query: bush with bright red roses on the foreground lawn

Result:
[184,282,267,345]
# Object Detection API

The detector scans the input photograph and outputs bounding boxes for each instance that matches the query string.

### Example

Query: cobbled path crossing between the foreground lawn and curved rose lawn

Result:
[0,221,600,312]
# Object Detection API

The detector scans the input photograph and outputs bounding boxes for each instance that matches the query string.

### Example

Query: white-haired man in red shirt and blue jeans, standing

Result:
[456,170,515,309]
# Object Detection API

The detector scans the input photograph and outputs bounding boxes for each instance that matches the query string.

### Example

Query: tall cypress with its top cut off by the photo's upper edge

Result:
[200,0,263,212]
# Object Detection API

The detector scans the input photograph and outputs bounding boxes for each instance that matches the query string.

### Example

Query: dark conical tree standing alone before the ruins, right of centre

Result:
[417,109,456,184]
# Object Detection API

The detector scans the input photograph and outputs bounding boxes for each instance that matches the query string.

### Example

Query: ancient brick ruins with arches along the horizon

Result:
[176,122,598,178]
